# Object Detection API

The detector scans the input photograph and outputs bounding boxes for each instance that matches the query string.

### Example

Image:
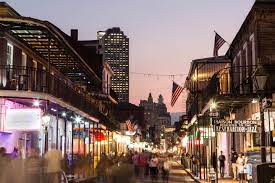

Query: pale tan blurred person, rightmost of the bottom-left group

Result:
[44,144,63,183]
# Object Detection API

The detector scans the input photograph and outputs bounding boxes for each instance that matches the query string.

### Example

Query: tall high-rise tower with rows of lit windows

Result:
[97,27,129,102]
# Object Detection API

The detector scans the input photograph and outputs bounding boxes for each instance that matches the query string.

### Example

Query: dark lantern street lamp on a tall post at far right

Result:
[252,65,268,163]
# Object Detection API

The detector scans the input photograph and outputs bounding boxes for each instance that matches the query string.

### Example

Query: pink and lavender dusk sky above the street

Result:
[4,0,254,112]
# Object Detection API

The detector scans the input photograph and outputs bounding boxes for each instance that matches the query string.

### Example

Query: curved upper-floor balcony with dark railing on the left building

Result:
[0,65,102,116]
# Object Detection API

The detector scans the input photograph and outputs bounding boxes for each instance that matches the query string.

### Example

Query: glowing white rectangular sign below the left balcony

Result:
[5,109,41,131]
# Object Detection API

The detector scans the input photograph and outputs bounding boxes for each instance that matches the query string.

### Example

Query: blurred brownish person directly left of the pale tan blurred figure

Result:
[25,148,43,183]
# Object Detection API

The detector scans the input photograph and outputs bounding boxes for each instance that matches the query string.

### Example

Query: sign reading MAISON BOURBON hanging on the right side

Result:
[213,119,261,133]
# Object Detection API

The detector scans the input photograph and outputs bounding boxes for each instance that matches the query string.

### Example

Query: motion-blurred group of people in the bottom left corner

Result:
[0,147,62,183]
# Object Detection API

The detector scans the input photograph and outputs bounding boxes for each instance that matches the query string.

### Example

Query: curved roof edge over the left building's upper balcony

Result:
[0,16,101,82]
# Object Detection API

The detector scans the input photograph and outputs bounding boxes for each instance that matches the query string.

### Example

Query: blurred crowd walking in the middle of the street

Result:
[96,151,175,183]
